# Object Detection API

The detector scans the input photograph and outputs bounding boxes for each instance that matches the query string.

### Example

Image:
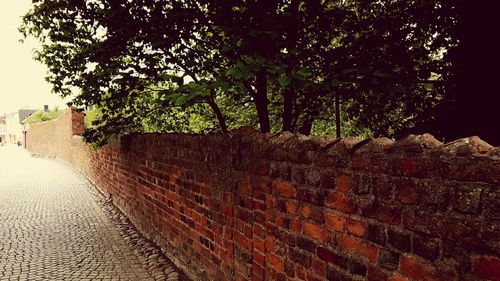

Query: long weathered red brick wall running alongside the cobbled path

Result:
[28,107,500,281]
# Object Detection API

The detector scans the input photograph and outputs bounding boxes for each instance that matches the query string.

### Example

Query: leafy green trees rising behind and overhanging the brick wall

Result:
[21,0,457,144]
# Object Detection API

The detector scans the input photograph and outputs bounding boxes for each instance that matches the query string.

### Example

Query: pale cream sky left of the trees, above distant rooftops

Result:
[0,0,68,115]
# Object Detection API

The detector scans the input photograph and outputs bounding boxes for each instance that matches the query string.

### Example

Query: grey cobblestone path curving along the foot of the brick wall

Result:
[0,146,188,280]
